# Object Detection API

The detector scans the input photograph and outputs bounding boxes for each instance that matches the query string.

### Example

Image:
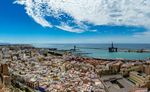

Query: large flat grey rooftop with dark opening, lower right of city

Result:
[101,75,134,92]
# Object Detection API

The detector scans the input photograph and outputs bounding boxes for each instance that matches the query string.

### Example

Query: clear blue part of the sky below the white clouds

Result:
[0,0,149,43]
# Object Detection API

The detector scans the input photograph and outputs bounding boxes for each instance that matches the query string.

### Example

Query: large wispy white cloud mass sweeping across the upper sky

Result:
[15,0,150,32]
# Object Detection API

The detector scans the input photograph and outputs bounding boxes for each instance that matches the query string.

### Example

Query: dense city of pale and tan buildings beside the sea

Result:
[0,45,149,92]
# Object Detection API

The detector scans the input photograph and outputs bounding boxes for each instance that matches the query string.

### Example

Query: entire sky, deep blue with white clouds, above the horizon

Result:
[0,0,150,43]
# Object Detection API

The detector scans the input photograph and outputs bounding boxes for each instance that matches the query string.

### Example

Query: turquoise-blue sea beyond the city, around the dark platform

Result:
[33,43,150,60]
